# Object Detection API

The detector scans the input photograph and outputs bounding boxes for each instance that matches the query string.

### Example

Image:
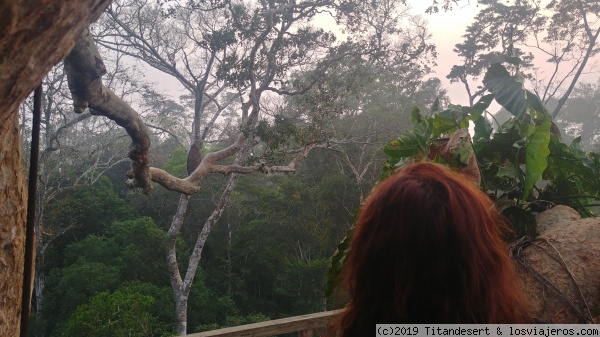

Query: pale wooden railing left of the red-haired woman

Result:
[187,310,339,337]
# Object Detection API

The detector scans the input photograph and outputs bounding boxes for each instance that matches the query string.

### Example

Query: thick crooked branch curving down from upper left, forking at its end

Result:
[65,30,316,195]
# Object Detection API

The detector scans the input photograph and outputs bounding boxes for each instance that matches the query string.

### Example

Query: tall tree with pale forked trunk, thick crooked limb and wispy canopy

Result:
[65,1,438,334]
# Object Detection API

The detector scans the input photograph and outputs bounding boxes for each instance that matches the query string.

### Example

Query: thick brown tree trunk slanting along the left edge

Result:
[0,0,110,336]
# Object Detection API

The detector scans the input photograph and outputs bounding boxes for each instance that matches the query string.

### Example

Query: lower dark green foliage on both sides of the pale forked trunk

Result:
[43,162,358,336]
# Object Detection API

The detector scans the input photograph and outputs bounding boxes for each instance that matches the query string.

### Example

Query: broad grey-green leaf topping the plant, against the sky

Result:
[483,63,529,117]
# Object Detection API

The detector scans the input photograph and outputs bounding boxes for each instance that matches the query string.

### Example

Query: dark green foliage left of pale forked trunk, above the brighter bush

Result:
[41,218,175,336]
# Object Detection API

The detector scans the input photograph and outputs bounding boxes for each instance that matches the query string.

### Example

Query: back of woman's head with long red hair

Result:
[340,163,527,337]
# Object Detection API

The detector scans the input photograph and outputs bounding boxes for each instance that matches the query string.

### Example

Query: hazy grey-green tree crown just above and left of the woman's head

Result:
[284,58,446,197]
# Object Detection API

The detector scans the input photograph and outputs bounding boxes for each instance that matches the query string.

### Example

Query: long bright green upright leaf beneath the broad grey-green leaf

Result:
[523,113,552,199]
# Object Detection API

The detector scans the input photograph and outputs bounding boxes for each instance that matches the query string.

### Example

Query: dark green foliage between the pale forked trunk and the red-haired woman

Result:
[200,165,359,318]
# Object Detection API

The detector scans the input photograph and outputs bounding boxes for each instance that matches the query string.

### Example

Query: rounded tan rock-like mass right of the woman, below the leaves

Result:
[516,206,600,323]
